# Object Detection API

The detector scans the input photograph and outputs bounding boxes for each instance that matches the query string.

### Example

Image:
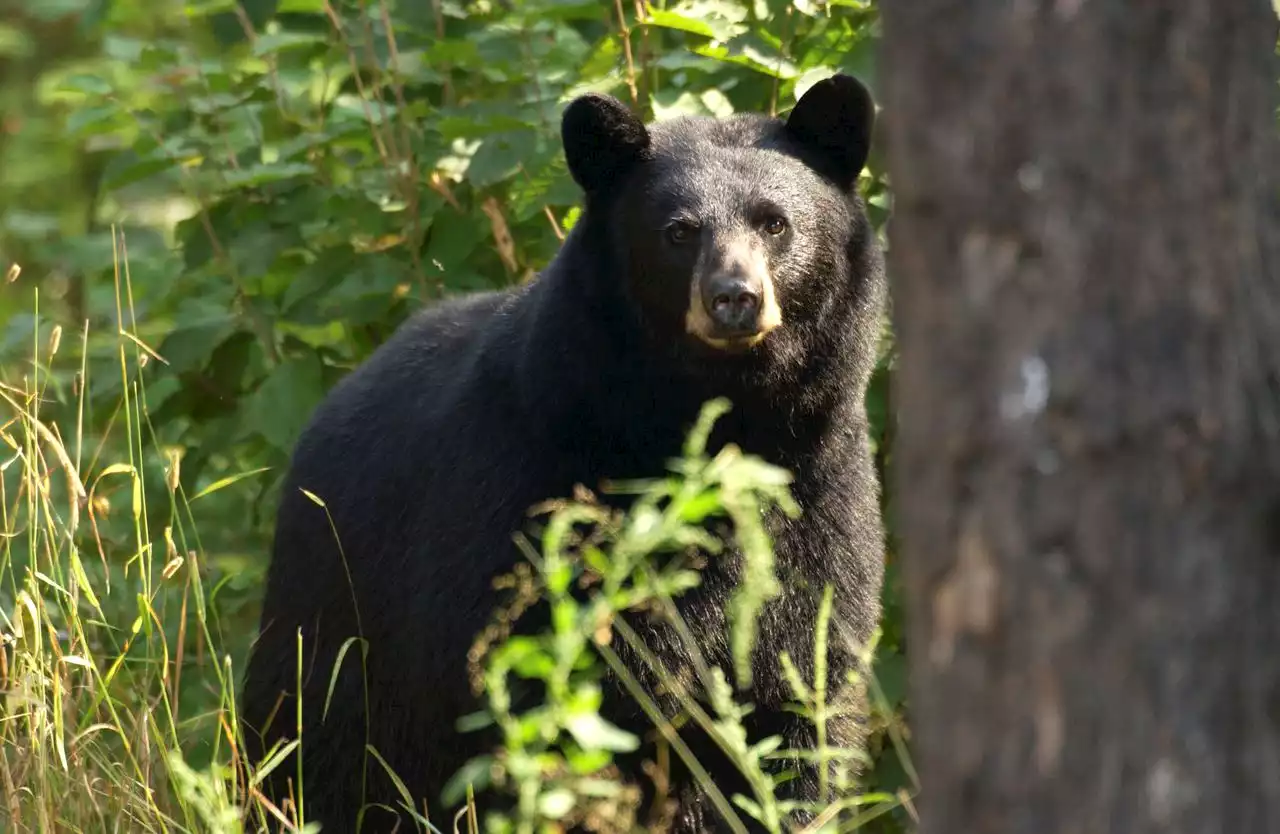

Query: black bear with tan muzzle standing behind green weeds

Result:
[242,75,886,831]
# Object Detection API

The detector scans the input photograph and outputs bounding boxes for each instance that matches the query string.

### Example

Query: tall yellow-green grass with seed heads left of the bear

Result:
[0,239,262,833]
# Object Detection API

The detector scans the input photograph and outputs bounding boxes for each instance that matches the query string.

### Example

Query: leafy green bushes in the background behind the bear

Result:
[0,0,884,573]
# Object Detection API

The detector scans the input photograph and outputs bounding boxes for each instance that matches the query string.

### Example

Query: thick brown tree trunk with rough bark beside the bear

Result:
[883,6,1280,834]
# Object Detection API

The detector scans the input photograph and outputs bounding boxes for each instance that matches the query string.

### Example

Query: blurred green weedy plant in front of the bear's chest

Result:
[451,400,900,834]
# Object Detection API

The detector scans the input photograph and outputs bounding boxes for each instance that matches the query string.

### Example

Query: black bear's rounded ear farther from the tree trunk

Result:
[561,93,649,194]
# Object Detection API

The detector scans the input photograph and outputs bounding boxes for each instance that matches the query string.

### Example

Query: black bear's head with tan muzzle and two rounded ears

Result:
[561,75,883,388]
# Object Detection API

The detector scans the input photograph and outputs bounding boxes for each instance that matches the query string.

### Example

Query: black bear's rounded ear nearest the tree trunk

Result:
[787,74,876,188]
